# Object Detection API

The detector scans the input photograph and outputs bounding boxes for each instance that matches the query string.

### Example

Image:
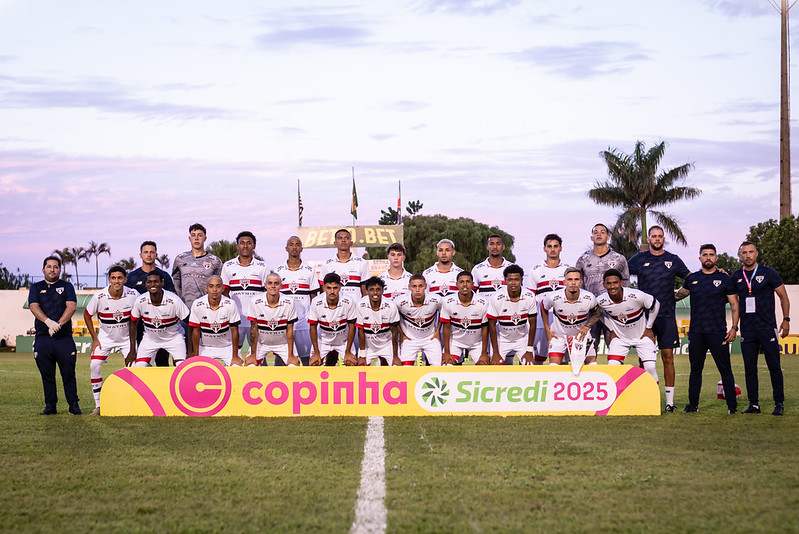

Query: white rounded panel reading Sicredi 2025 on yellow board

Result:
[414,371,617,413]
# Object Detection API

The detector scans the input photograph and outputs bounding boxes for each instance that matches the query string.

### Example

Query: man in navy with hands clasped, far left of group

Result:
[28,256,83,415]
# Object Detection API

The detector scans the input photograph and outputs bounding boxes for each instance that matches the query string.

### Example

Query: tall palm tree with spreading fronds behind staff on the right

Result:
[588,141,702,245]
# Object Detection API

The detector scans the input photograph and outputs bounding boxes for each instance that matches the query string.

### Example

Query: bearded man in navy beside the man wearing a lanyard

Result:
[674,244,738,414]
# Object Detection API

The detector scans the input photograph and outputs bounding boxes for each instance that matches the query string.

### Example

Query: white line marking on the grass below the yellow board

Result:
[350,416,388,534]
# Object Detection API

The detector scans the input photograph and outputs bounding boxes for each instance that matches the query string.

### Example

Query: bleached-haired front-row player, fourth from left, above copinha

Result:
[247,273,300,366]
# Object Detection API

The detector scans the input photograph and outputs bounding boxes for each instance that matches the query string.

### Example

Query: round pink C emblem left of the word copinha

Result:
[169,356,233,417]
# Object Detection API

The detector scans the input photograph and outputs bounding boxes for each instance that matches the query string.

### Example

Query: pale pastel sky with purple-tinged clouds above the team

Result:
[0,0,792,284]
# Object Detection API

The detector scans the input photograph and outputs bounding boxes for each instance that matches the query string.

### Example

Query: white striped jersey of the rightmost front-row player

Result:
[596,287,660,341]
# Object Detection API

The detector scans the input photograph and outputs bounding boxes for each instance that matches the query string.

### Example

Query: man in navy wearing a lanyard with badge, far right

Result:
[732,241,791,415]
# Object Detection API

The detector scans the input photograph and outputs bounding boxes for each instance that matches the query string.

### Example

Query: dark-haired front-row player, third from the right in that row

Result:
[486,264,538,365]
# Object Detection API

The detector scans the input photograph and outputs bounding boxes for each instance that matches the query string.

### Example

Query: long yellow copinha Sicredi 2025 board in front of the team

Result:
[101,357,660,417]
